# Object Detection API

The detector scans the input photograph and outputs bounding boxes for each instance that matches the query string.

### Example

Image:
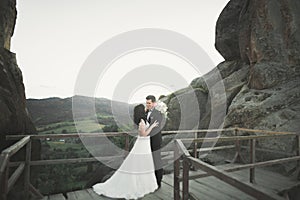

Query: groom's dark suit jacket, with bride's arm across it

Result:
[149,108,162,151]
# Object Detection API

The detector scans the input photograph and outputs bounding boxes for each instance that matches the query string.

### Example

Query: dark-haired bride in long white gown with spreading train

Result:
[93,104,158,199]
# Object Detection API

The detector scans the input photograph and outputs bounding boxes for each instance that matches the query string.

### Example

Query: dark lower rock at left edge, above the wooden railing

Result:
[0,49,36,150]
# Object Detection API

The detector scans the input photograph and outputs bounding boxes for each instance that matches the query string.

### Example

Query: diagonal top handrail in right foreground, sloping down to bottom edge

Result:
[189,157,280,200]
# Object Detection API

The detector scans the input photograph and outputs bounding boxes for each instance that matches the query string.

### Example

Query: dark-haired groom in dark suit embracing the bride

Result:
[146,95,163,188]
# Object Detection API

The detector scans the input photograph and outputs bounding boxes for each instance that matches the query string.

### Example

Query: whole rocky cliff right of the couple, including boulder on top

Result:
[167,0,300,166]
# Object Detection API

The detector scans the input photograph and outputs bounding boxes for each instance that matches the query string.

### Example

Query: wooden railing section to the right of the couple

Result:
[174,128,300,200]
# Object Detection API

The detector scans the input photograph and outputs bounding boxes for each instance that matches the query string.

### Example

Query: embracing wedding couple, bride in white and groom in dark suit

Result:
[93,95,163,199]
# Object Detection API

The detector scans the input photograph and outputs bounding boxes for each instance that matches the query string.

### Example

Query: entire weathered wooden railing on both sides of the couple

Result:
[0,128,300,200]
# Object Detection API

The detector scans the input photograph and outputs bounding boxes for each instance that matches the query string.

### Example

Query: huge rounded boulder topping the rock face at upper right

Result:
[215,0,300,65]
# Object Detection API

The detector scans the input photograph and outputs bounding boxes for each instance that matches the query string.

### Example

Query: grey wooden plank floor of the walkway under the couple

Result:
[43,165,300,200]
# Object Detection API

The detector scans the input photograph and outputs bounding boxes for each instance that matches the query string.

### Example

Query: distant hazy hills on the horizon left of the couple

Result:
[26,96,133,131]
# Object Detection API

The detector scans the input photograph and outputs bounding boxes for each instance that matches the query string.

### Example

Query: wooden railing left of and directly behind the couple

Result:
[0,130,202,200]
